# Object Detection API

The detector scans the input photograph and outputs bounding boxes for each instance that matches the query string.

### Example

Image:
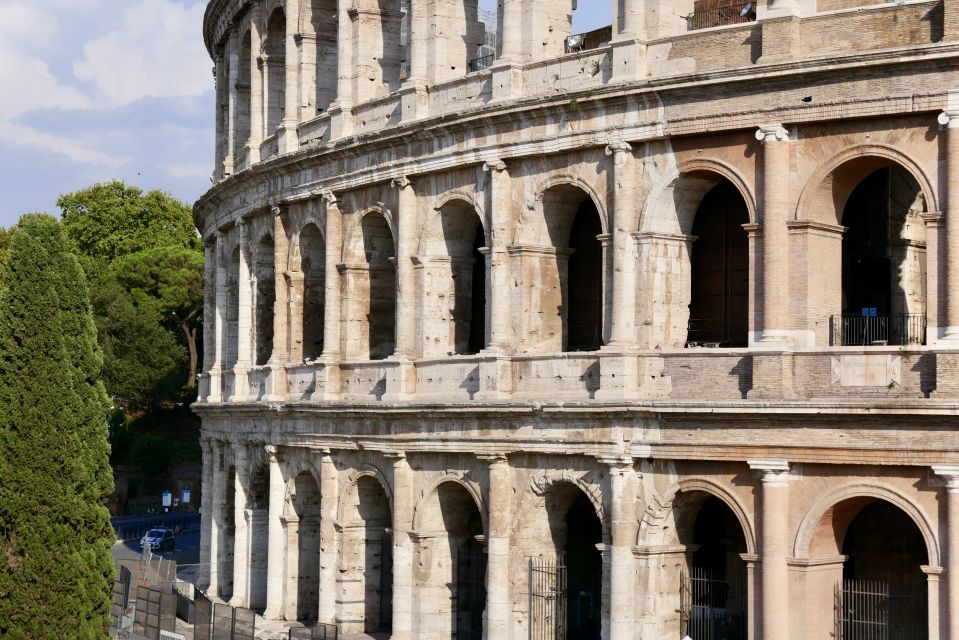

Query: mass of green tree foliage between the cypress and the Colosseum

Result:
[57,181,203,404]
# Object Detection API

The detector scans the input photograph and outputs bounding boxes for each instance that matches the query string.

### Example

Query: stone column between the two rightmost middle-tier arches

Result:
[756,124,790,347]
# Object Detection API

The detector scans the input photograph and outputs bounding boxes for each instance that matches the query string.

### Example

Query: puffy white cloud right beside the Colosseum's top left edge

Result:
[73,0,213,106]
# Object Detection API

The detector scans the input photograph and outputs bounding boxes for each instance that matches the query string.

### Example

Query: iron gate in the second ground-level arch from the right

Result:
[679,567,747,640]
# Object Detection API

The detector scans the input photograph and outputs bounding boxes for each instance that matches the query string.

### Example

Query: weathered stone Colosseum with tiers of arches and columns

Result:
[195,0,959,640]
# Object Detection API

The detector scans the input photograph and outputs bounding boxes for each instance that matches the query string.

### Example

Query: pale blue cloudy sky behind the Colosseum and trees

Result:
[0,0,610,227]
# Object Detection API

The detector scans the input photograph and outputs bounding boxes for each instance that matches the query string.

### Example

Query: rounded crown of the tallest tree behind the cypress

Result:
[57,180,202,275]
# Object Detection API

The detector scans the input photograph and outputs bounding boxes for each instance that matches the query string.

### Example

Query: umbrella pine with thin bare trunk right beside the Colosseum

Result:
[112,246,203,388]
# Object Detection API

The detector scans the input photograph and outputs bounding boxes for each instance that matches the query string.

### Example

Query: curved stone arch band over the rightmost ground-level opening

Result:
[793,482,941,567]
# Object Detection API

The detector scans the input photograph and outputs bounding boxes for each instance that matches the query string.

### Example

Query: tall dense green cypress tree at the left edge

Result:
[0,216,113,639]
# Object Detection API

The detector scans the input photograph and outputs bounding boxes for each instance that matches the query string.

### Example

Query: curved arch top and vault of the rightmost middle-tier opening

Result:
[795,144,939,225]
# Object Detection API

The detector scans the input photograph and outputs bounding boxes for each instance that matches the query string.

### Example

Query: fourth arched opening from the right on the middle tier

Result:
[417,200,486,357]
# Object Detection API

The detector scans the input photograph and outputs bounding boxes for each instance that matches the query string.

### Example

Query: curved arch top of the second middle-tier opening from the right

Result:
[638,158,758,235]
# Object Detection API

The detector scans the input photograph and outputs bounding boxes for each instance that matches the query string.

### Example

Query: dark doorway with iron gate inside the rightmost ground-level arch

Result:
[837,500,929,640]
